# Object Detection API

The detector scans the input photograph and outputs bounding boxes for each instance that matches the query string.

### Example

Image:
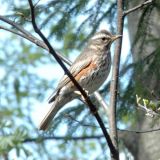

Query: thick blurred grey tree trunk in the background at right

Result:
[123,0,160,160]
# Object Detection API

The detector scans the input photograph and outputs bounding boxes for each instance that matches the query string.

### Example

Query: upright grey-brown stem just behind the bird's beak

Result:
[109,0,124,160]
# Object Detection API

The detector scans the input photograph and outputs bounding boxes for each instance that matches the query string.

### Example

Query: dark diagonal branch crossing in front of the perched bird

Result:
[28,0,116,155]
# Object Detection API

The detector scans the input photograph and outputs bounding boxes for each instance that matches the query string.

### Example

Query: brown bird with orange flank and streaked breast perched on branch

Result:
[39,29,122,130]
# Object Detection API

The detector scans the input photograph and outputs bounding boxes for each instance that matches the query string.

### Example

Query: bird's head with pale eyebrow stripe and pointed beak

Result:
[89,30,122,49]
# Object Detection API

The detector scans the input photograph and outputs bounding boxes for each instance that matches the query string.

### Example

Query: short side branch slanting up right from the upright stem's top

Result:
[123,0,154,17]
